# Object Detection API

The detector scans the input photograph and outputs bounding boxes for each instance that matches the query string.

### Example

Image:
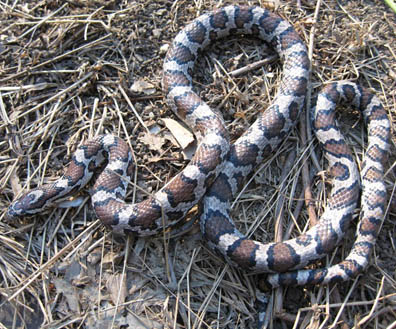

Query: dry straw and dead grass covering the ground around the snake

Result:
[0,0,396,328]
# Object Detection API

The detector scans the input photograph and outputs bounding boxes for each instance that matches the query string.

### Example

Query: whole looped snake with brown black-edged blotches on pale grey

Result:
[6,5,390,285]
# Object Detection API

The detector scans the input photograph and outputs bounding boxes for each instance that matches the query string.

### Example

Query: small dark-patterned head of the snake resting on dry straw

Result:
[6,189,45,219]
